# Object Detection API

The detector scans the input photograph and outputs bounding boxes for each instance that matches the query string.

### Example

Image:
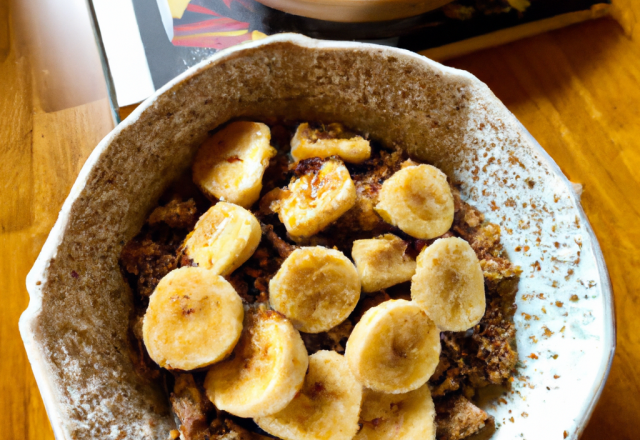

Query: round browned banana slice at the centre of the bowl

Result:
[269,246,360,333]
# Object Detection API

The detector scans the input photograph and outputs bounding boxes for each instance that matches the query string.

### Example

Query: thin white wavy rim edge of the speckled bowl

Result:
[20,34,616,440]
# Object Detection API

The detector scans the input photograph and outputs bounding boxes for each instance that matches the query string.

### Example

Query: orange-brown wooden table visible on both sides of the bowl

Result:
[0,0,640,440]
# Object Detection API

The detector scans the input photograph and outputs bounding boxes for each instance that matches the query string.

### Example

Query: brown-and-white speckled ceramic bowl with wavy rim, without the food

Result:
[20,34,615,440]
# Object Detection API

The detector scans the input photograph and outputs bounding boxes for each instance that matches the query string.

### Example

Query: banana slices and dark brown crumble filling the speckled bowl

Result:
[120,121,519,440]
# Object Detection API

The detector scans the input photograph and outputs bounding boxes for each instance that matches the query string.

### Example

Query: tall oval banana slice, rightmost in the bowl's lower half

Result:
[411,237,486,332]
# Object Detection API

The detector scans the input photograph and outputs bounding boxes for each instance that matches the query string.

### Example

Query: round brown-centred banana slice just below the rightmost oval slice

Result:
[345,300,440,394]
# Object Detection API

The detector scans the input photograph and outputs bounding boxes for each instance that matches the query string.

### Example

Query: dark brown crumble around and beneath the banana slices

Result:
[120,123,520,440]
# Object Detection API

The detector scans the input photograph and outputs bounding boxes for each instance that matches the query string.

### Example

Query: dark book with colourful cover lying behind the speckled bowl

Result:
[89,0,610,118]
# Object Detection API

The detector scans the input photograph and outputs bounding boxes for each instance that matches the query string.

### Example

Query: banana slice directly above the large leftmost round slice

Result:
[184,202,262,275]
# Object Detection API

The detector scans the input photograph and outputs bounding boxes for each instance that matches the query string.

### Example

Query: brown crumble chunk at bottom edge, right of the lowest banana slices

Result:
[435,394,495,440]
